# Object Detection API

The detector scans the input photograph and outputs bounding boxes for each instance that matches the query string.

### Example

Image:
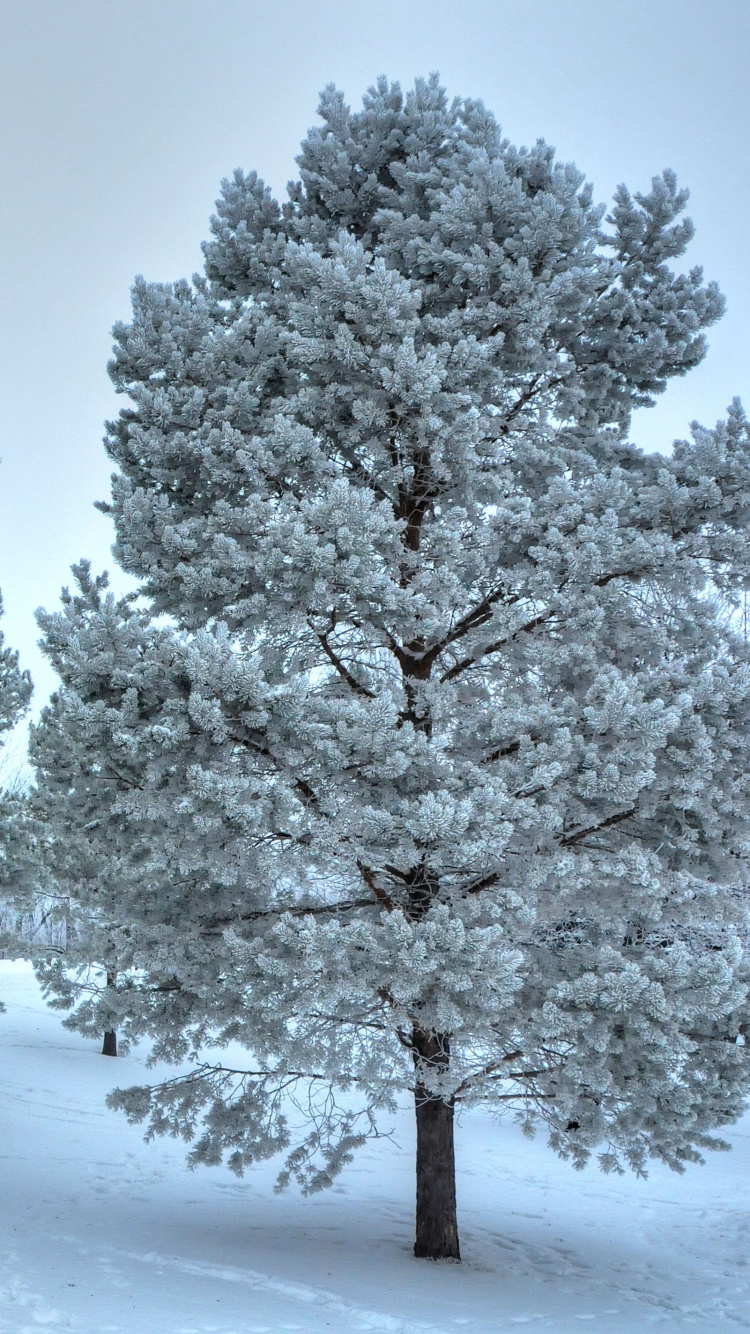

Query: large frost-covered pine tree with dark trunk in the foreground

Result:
[33,79,750,1258]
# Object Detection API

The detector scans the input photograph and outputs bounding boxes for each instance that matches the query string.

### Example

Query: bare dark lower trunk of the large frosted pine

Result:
[414,1034,460,1259]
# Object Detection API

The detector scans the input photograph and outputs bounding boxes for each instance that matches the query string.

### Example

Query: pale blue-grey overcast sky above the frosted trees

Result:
[0,0,750,752]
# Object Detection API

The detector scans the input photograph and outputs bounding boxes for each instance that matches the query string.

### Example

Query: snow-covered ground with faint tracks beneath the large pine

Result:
[0,962,750,1334]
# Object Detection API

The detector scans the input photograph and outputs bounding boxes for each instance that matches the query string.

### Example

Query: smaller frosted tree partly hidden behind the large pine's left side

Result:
[27,560,143,1057]
